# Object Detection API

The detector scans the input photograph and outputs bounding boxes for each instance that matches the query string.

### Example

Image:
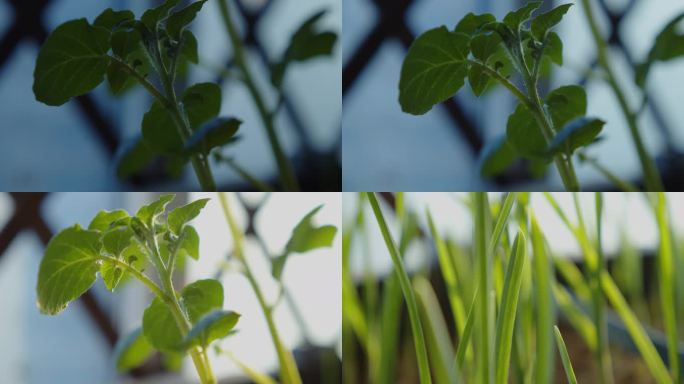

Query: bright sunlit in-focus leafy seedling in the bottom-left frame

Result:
[37,195,240,384]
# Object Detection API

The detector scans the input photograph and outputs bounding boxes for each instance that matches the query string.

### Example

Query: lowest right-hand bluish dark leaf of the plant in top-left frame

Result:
[185,117,242,154]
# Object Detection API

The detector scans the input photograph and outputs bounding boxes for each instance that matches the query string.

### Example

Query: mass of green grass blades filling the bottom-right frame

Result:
[343,193,681,384]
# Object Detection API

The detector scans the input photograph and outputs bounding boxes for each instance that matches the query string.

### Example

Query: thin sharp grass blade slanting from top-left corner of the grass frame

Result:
[367,192,432,384]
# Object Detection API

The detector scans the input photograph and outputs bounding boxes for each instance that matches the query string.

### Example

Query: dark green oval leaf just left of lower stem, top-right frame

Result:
[506,104,547,159]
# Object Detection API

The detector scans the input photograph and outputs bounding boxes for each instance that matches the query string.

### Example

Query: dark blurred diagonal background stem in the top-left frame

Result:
[218,0,299,191]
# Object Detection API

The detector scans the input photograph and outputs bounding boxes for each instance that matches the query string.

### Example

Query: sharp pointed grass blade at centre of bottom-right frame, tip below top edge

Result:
[495,232,527,384]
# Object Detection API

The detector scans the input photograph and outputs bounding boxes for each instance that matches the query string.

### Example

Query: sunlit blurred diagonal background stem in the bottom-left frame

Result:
[218,193,302,384]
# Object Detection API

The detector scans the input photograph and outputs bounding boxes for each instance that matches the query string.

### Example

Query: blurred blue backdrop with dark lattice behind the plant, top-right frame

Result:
[342,0,684,191]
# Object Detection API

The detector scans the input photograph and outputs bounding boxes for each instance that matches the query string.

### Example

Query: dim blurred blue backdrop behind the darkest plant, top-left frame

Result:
[0,0,342,191]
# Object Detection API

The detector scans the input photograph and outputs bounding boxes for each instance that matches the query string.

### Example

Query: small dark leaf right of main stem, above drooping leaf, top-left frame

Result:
[182,83,221,129]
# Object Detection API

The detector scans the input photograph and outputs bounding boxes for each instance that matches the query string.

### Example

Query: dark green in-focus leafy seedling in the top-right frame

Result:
[399,1,604,191]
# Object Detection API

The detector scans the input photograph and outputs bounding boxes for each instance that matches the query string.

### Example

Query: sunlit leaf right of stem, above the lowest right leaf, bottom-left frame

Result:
[181,279,223,324]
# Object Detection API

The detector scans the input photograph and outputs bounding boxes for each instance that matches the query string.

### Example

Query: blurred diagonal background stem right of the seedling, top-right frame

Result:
[582,0,664,192]
